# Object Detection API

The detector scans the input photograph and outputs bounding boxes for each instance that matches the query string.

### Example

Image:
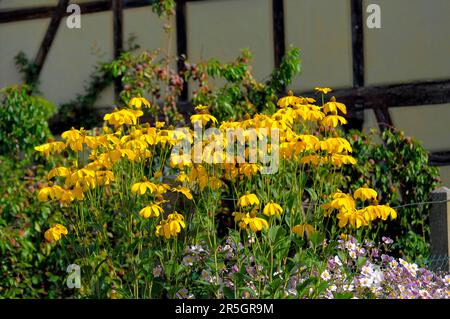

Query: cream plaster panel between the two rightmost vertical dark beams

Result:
[285,0,353,91]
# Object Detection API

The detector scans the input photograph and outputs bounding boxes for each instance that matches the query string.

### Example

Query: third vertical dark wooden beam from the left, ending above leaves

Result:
[272,0,286,68]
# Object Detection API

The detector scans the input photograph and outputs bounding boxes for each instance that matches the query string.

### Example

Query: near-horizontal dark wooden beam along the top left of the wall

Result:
[0,0,153,23]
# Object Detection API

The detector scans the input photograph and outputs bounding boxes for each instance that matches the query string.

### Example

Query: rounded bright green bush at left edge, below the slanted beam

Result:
[0,85,55,158]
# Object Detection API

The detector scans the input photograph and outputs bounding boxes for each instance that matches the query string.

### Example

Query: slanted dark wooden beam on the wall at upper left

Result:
[34,0,69,78]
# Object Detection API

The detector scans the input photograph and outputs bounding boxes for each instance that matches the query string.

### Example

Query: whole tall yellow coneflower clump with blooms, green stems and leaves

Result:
[36,88,445,298]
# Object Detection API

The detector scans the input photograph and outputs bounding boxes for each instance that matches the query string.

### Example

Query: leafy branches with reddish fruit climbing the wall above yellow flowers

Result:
[104,48,300,123]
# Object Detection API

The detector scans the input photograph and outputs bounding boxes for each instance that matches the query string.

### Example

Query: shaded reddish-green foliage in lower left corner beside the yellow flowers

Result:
[0,156,70,298]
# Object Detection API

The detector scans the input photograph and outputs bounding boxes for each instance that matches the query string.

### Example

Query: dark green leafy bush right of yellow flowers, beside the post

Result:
[346,129,439,263]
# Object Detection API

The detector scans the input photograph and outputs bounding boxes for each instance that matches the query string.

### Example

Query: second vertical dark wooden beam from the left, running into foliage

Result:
[175,0,188,101]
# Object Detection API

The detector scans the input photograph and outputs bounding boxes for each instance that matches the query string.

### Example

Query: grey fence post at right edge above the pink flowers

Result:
[430,187,450,272]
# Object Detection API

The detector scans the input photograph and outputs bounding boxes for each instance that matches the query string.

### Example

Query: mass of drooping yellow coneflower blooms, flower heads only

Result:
[35,88,386,242]
